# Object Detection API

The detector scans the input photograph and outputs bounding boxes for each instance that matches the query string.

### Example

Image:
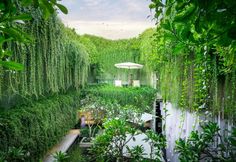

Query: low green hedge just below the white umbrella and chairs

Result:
[84,85,156,110]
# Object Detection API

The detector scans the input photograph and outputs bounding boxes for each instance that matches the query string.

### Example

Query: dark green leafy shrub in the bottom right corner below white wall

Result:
[175,122,236,162]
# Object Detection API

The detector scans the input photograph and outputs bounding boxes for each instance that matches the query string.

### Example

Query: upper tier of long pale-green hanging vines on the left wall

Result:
[0,2,89,107]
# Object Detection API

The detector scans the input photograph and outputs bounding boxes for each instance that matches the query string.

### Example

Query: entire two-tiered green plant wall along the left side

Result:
[0,1,89,161]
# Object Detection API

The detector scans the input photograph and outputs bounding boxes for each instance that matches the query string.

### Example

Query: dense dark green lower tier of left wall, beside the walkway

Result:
[0,92,79,161]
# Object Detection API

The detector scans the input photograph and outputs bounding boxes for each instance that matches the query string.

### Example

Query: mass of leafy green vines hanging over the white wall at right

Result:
[150,0,236,118]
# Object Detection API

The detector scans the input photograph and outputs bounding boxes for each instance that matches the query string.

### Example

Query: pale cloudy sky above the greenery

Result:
[59,0,155,40]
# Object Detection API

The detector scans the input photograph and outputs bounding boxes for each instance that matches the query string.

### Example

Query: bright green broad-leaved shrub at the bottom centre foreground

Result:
[92,119,136,161]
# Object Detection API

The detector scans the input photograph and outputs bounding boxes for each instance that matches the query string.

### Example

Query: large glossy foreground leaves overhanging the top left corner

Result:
[0,0,68,70]
